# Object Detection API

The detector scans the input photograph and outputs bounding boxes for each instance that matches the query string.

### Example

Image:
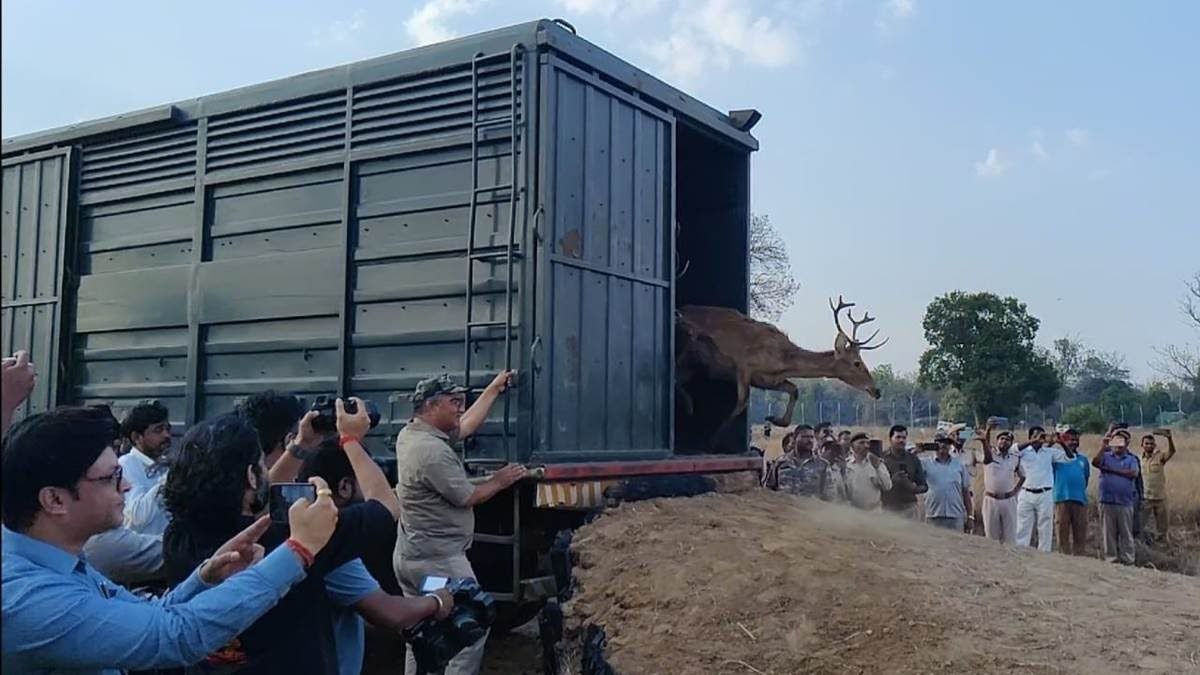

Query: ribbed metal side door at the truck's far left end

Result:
[0,148,73,420]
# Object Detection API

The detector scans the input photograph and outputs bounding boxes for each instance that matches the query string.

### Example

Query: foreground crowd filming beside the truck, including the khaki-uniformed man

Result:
[0,352,526,675]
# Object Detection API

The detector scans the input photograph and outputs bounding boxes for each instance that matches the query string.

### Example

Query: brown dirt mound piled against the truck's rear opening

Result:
[566,490,1200,675]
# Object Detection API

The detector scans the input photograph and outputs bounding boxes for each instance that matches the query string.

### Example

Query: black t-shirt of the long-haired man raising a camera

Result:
[163,500,396,675]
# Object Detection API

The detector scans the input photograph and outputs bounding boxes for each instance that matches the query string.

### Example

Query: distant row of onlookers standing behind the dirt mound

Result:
[762,420,1175,565]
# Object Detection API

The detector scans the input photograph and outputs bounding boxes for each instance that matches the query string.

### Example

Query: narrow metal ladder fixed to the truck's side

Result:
[463,43,524,602]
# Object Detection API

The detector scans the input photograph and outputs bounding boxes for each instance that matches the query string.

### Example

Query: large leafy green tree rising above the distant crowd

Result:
[920,291,1062,422]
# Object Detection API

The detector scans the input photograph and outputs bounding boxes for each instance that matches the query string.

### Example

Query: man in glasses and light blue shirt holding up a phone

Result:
[0,407,337,674]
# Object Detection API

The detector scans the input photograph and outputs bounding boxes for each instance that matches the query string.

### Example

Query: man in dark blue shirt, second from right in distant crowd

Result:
[1092,429,1139,565]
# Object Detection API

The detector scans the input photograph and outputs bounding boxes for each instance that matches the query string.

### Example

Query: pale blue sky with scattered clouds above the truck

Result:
[0,0,1200,382]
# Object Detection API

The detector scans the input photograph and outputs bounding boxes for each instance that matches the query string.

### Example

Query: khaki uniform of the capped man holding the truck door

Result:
[392,419,487,675]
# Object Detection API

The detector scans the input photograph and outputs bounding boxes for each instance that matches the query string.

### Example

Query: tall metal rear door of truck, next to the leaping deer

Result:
[534,54,674,461]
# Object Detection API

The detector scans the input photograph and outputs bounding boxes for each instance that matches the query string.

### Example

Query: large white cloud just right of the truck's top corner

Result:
[646,0,799,84]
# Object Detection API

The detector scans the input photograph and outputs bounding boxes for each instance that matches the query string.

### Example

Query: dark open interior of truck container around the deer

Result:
[674,123,750,454]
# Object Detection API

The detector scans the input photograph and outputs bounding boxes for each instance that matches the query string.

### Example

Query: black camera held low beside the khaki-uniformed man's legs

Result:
[404,578,496,673]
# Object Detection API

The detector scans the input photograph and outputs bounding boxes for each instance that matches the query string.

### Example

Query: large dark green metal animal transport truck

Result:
[0,19,761,623]
